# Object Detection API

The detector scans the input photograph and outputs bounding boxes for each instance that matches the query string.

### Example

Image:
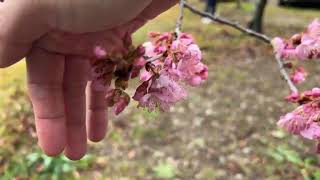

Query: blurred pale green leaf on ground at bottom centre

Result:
[153,162,176,179]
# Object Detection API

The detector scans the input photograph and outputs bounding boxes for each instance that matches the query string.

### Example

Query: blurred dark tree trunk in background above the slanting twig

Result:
[249,0,268,33]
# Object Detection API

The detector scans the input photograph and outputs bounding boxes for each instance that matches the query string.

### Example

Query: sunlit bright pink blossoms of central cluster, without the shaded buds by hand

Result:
[133,33,208,111]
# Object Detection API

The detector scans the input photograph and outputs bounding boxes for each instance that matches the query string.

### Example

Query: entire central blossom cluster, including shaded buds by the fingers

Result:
[91,32,208,115]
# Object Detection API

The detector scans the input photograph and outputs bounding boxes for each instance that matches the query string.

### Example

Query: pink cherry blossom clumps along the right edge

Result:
[272,19,320,152]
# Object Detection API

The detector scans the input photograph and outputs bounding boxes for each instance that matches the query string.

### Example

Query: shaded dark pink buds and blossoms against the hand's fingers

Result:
[91,35,145,115]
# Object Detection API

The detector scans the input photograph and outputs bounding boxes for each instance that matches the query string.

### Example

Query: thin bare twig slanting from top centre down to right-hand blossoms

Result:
[184,3,271,44]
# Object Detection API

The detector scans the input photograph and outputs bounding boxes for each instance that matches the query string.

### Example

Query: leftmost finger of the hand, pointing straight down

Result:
[27,49,66,156]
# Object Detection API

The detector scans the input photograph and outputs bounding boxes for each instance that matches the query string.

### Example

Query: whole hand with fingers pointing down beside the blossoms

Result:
[0,0,177,160]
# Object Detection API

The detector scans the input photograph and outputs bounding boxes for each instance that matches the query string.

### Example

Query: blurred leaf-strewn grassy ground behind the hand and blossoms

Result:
[0,0,320,180]
